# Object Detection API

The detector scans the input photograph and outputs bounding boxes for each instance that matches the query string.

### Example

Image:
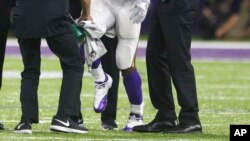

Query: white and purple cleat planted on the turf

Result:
[123,113,143,132]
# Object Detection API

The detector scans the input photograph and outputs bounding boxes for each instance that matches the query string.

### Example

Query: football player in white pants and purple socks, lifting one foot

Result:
[79,0,150,131]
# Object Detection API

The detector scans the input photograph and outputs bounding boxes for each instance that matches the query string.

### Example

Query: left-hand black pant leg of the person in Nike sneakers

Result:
[18,39,41,123]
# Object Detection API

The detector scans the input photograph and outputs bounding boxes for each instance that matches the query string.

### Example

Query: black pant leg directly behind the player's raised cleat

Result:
[101,36,120,121]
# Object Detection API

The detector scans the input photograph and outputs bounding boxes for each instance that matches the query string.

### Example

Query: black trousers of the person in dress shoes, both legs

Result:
[146,0,200,124]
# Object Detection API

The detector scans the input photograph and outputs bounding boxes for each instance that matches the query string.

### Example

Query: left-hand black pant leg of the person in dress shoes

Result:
[146,5,177,121]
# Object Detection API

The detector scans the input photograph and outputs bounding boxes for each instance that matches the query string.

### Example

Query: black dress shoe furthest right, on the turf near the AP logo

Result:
[163,124,202,133]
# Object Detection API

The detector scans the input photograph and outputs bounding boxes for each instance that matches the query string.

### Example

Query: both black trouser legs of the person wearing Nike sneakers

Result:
[18,33,83,123]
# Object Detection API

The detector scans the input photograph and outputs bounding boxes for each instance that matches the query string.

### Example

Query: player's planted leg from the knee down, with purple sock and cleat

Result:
[116,39,143,132]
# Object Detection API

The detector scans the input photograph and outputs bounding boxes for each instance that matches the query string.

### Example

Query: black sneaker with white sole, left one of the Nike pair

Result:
[14,121,32,134]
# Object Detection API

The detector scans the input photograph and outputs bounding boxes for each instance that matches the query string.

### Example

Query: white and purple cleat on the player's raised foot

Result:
[94,74,113,113]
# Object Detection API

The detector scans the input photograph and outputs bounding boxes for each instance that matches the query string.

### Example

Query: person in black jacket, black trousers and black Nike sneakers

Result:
[13,0,90,133]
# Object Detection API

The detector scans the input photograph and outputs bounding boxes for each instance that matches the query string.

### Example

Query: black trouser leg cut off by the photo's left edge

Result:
[0,0,11,89]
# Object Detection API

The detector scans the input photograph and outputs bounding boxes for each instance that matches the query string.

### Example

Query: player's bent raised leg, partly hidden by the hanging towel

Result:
[90,0,115,113]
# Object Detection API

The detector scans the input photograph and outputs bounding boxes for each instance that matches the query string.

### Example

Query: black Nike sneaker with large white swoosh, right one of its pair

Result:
[50,117,88,134]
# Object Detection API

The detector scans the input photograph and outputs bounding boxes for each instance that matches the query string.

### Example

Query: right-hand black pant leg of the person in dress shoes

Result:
[160,0,200,124]
